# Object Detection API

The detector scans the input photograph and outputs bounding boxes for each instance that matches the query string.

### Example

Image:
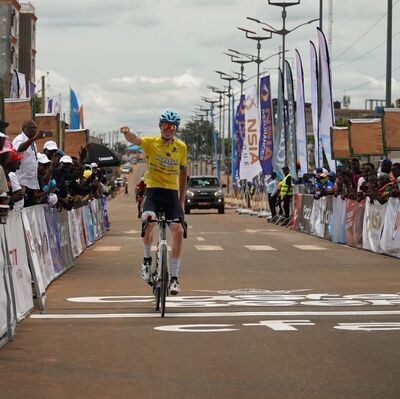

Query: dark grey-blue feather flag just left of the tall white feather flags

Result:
[285,60,297,176]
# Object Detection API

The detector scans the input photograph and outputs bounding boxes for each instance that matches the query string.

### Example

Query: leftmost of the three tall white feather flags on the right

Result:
[296,50,308,176]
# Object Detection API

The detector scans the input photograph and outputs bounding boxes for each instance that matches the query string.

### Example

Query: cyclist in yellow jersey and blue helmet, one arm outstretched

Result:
[121,111,187,295]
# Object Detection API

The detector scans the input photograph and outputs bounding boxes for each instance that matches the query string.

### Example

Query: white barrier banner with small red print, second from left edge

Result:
[4,212,33,321]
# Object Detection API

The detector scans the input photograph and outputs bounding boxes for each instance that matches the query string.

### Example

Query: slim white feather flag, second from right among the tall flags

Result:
[310,41,323,168]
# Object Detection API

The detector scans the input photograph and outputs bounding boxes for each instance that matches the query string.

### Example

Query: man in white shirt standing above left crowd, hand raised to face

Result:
[12,120,40,207]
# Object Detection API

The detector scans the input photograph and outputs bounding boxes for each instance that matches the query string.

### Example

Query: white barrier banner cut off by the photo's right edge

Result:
[380,198,400,258]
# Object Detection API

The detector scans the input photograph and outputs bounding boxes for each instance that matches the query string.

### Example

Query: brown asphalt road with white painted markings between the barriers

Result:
[0,176,400,399]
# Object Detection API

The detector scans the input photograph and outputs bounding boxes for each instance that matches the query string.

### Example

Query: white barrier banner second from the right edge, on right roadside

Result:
[363,198,387,253]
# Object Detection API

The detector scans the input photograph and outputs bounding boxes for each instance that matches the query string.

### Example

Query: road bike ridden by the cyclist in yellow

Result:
[142,212,187,317]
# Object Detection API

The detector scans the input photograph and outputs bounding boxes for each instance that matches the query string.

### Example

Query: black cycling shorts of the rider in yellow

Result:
[143,188,184,220]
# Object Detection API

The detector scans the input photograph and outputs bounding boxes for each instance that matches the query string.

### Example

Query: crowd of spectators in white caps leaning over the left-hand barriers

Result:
[0,120,109,223]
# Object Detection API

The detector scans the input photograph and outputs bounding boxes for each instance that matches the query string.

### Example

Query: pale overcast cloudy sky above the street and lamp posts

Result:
[31,0,400,141]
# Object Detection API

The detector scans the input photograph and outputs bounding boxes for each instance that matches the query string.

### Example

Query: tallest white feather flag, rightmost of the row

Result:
[317,28,336,171]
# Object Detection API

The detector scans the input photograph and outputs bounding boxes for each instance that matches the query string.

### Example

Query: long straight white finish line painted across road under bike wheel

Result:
[30,310,400,320]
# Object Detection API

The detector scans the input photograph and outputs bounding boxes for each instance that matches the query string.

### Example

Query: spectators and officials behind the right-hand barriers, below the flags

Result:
[234,158,400,224]
